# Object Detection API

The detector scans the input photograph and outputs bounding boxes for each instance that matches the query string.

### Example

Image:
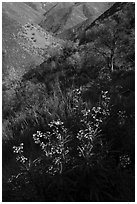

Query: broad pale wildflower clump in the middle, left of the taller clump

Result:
[33,120,71,174]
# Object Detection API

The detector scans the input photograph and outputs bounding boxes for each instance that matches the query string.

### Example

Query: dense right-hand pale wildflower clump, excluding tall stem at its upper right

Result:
[77,107,102,163]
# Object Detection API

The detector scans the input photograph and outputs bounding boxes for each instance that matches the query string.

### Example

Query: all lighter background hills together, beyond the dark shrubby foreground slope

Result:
[2,2,115,79]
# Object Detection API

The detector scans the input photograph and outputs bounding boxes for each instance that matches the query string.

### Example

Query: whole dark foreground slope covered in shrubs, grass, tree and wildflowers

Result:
[2,3,135,202]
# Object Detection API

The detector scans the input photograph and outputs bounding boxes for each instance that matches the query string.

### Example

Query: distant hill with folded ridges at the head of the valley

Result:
[40,2,113,34]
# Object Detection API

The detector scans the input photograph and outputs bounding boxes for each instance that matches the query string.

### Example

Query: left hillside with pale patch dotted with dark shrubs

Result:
[2,2,61,81]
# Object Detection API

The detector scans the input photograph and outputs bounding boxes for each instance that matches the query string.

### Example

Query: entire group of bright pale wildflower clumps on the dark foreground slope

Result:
[10,88,109,178]
